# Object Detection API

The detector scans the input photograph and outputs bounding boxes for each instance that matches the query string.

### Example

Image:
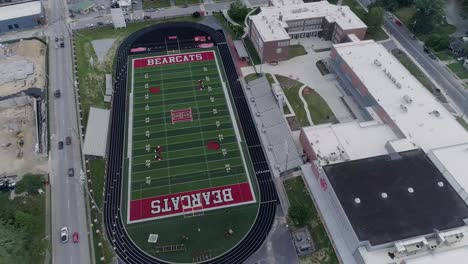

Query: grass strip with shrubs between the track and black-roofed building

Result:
[284,177,338,264]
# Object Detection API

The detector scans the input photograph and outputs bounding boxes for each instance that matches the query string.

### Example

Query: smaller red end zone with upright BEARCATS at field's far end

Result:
[133,51,215,68]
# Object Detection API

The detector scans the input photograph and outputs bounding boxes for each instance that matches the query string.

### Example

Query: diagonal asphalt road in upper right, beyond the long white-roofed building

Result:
[384,17,468,114]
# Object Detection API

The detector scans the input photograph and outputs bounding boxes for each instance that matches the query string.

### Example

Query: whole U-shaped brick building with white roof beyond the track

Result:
[248,0,367,62]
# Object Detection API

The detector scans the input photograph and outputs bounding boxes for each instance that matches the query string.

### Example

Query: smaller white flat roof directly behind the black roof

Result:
[303,121,397,165]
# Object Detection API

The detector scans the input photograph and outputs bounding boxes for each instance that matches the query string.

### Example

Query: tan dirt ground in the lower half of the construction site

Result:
[0,101,48,176]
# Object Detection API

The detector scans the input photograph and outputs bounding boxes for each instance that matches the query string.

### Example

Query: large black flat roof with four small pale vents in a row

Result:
[323,149,468,246]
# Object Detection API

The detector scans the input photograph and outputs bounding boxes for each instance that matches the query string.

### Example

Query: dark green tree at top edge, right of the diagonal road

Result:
[411,0,444,33]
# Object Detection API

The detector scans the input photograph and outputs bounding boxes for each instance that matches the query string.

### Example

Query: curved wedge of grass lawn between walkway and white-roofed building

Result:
[302,87,336,125]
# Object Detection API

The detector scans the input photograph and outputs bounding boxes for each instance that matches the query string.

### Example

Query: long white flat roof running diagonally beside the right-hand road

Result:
[332,40,468,152]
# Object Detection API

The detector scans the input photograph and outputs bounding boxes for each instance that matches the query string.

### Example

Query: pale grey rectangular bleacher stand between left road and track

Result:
[83,107,110,157]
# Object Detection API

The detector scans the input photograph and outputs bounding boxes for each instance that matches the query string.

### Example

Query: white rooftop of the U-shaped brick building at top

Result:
[250,0,367,41]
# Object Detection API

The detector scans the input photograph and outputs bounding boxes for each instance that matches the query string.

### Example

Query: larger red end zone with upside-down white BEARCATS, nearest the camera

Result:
[129,182,255,222]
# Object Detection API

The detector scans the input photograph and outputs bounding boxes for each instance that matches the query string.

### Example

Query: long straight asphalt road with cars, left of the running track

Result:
[46,0,90,264]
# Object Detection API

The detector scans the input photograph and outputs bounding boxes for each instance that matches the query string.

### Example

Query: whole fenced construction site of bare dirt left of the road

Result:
[0,39,48,177]
